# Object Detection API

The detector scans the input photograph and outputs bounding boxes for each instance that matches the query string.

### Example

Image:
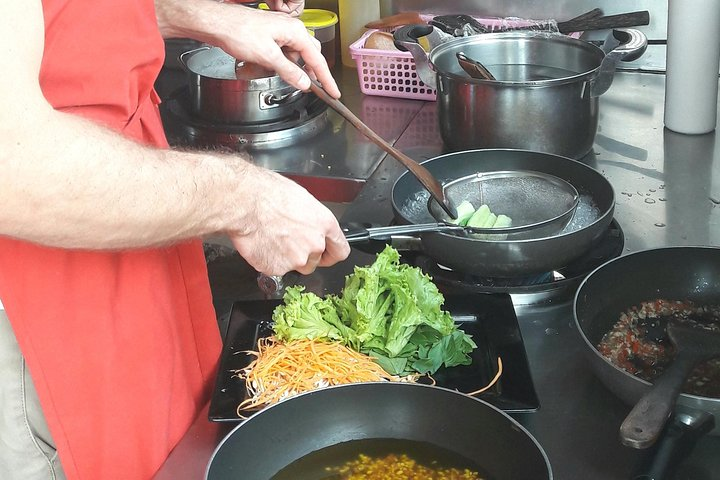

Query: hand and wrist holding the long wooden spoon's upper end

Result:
[155,0,340,98]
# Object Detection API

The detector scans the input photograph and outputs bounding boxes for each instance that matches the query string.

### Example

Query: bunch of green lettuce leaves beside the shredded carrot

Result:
[273,246,476,375]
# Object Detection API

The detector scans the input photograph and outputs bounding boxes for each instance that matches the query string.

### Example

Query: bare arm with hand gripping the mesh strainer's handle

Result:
[0,0,349,274]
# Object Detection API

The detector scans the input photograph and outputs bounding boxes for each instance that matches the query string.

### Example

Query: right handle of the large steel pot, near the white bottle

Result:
[590,28,648,97]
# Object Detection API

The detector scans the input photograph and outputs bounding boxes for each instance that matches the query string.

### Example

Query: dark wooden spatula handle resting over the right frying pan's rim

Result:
[620,350,697,448]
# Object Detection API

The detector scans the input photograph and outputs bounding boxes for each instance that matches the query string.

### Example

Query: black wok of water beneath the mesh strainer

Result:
[392,149,615,277]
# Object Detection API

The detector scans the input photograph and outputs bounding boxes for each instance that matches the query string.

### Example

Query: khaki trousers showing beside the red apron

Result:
[0,310,65,480]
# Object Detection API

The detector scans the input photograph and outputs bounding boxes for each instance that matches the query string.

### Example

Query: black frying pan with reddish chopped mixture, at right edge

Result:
[574,247,720,478]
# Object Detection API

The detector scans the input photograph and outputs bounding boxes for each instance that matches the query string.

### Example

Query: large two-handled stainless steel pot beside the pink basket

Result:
[395,25,647,159]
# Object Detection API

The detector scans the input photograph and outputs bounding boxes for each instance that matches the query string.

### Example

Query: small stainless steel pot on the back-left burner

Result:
[180,46,308,124]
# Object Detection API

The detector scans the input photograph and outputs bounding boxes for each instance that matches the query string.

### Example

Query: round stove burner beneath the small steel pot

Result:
[160,87,327,150]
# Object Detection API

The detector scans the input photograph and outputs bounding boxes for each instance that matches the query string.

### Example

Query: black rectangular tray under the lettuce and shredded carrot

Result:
[208,293,540,422]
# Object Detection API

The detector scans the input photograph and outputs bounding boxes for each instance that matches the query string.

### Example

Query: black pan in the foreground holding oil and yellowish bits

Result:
[205,382,552,480]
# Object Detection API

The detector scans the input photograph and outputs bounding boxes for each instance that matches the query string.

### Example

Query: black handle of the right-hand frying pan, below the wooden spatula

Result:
[633,406,715,480]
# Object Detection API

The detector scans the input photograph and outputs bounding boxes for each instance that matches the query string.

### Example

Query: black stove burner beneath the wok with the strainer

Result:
[402,220,625,300]
